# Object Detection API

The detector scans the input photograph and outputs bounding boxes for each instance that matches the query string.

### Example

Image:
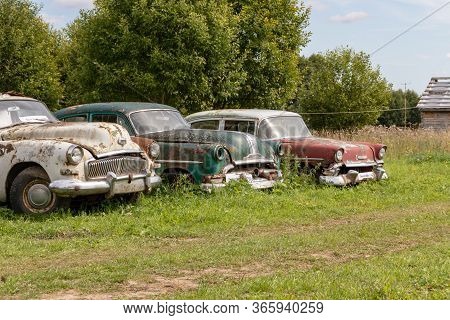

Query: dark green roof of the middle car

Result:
[55,102,178,117]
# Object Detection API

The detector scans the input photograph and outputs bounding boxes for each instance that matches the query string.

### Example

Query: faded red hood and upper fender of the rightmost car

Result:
[279,137,383,164]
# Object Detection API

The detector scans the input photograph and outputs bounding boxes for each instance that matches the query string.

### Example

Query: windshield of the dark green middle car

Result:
[130,110,189,134]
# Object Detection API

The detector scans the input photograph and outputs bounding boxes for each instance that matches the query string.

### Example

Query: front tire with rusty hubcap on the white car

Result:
[9,167,70,215]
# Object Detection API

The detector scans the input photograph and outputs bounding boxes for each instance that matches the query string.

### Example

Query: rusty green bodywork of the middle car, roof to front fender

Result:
[55,102,278,183]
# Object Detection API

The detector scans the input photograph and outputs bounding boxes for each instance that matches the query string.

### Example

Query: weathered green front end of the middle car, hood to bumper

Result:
[144,129,281,190]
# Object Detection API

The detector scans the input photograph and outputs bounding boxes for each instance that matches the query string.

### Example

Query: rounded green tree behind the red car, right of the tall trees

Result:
[291,48,391,129]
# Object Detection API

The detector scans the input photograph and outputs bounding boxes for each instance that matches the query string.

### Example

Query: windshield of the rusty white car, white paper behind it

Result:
[0,100,58,128]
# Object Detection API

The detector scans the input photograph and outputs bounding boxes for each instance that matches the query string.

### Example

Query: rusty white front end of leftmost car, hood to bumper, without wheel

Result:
[3,122,161,198]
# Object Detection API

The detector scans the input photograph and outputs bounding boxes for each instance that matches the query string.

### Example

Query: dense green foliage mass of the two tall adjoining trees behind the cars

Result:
[64,0,309,112]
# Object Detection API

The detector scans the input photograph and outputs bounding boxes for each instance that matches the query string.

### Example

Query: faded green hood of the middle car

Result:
[141,129,274,162]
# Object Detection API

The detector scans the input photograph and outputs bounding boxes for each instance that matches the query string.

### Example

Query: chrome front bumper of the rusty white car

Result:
[49,172,161,198]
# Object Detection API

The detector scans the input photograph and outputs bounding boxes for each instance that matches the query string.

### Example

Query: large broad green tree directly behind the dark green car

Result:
[65,0,245,112]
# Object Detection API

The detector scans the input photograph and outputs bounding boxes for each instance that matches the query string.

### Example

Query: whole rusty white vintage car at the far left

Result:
[0,94,161,214]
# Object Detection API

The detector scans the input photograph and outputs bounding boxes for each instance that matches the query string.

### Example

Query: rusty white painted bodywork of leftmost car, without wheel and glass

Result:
[0,96,160,206]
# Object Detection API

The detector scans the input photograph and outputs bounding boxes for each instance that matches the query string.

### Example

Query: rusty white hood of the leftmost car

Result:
[1,122,140,156]
